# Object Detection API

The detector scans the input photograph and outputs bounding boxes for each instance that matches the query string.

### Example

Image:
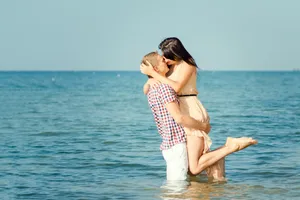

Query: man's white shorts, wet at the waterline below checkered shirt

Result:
[162,143,188,181]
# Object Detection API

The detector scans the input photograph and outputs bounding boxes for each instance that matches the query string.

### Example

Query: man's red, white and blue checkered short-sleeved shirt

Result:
[147,84,186,150]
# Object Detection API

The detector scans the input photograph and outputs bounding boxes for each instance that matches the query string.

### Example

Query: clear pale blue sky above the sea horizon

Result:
[0,0,300,70]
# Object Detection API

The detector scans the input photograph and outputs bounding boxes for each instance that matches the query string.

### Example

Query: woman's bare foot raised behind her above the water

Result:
[225,137,257,152]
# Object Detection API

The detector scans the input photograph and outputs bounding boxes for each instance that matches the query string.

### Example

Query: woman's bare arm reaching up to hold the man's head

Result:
[141,63,195,93]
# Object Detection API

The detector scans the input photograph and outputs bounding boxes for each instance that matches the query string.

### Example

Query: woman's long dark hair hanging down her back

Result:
[158,37,198,68]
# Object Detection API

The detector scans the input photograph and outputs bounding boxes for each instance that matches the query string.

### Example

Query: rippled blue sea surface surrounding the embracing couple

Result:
[0,71,300,200]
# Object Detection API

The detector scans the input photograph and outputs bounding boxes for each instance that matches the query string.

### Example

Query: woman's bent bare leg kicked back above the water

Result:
[187,136,257,175]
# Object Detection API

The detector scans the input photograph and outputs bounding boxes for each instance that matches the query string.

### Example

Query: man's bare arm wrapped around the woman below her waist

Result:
[166,101,210,134]
